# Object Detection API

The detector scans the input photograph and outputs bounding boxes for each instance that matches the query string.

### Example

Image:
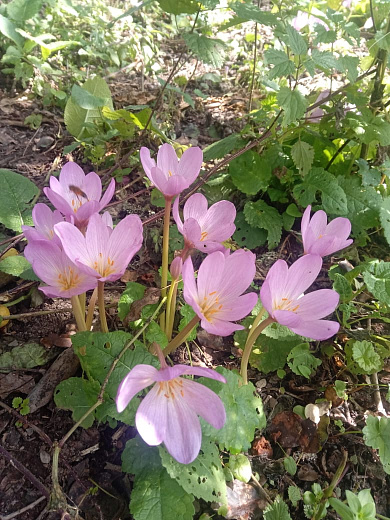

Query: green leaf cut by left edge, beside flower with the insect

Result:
[0,168,39,233]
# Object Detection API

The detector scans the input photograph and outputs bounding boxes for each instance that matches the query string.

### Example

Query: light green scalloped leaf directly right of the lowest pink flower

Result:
[199,367,266,453]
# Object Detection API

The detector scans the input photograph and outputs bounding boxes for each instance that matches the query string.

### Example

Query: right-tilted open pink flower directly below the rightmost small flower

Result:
[260,255,340,340]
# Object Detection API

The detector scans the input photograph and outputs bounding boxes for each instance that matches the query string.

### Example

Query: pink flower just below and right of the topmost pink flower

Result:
[172,193,236,253]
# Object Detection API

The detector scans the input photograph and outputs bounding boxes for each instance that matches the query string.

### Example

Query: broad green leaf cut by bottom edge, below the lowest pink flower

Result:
[130,468,195,520]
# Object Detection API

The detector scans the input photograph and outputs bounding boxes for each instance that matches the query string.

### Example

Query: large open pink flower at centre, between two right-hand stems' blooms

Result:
[182,249,257,336]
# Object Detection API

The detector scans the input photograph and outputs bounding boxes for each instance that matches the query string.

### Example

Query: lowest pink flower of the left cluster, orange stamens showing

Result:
[24,240,97,298]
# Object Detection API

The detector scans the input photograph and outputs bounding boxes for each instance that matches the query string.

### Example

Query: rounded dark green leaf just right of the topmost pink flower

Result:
[229,150,272,195]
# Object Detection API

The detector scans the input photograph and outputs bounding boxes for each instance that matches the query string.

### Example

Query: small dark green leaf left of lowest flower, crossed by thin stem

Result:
[54,377,100,428]
